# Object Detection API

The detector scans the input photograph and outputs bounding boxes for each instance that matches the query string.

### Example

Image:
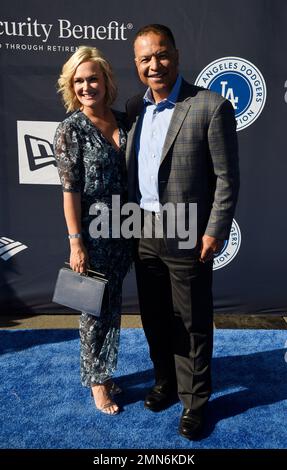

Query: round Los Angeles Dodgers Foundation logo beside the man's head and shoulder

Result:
[195,57,267,131]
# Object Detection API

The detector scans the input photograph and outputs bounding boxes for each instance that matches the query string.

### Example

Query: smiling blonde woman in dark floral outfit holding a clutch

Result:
[54,46,130,415]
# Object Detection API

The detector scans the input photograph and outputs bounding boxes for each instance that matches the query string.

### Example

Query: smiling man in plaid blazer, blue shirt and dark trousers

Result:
[127,24,239,439]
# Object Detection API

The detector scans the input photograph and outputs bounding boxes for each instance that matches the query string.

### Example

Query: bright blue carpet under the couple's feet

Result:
[0,329,287,449]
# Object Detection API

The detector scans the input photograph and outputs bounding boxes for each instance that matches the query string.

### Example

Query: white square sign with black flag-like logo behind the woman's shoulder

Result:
[17,121,60,184]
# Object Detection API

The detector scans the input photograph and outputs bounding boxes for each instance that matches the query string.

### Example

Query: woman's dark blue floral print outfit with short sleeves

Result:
[54,110,131,387]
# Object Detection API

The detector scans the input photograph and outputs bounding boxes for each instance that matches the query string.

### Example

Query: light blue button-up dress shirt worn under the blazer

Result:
[136,75,182,212]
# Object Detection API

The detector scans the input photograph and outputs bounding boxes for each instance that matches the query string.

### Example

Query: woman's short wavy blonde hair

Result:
[58,46,117,112]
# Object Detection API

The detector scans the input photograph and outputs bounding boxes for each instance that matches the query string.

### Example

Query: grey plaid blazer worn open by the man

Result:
[126,80,239,251]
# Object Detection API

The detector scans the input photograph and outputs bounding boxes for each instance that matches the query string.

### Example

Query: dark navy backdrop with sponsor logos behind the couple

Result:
[0,0,287,314]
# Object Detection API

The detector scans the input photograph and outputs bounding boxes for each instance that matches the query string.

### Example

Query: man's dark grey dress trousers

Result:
[135,233,213,410]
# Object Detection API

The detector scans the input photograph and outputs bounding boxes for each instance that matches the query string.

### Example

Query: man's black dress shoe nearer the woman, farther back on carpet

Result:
[144,384,178,411]
